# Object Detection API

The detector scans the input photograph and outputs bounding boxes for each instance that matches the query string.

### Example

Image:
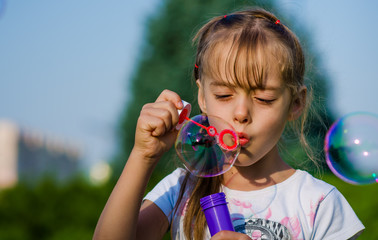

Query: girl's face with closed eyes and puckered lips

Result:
[197,51,306,166]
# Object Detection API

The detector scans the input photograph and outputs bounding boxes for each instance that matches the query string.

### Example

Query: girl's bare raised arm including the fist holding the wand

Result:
[94,90,183,240]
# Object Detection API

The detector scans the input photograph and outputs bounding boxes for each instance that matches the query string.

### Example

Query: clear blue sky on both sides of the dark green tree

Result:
[0,0,378,169]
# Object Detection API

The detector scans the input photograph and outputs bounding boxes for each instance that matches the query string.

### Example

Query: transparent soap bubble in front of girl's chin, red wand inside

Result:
[175,115,240,177]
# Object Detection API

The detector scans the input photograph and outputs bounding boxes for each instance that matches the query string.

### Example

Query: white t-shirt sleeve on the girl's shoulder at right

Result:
[311,188,364,240]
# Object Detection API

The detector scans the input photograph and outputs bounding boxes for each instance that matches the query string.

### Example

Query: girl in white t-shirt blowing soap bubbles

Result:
[95,9,364,240]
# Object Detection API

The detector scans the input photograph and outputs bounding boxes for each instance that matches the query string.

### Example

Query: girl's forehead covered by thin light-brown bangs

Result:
[201,40,283,89]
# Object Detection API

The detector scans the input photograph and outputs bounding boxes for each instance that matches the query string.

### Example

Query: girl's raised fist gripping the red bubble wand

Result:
[133,90,183,164]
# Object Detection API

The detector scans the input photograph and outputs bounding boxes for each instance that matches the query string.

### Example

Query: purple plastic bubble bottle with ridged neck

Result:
[200,192,235,236]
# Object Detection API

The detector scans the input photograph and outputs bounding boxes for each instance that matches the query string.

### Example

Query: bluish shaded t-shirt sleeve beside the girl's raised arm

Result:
[143,168,185,223]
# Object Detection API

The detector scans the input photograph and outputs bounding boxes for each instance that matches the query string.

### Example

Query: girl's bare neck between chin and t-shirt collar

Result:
[223,147,295,191]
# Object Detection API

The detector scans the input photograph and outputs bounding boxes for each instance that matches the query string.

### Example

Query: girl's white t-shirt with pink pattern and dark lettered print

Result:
[145,168,364,240]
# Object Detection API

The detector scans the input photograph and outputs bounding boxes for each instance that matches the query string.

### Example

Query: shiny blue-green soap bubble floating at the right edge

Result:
[324,113,378,184]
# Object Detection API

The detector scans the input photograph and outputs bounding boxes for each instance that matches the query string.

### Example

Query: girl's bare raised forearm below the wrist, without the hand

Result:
[94,151,154,239]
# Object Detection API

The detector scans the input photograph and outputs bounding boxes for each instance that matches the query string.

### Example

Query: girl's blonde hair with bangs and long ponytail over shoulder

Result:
[175,9,315,239]
